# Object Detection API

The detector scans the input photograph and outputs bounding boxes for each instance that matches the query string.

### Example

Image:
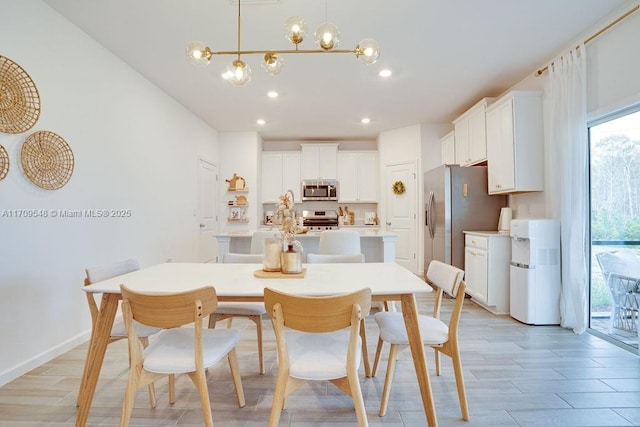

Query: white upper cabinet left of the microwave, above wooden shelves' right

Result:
[262,151,301,203]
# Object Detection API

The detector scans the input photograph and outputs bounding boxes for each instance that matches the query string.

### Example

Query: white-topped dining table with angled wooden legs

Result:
[76,263,437,426]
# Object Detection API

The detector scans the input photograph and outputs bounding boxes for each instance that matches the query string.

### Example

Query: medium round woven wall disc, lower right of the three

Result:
[20,131,73,190]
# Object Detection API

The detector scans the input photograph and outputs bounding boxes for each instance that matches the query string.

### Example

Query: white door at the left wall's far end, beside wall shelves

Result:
[198,158,218,262]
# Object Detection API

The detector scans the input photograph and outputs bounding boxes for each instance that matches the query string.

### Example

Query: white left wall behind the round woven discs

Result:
[0,0,218,384]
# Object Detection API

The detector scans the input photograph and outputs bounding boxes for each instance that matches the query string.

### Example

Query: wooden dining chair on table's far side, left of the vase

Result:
[209,253,267,374]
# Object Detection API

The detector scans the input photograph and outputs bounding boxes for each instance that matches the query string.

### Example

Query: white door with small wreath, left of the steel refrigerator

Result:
[384,163,418,273]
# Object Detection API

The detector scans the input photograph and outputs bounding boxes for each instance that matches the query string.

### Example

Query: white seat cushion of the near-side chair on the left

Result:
[143,327,240,374]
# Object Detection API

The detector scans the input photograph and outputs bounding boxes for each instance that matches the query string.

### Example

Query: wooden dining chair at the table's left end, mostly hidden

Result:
[78,259,162,408]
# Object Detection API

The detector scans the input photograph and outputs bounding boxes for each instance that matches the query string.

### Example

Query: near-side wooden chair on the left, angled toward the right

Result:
[120,285,245,427]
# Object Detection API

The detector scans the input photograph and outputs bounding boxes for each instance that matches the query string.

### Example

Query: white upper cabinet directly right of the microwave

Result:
[338,151,378,203]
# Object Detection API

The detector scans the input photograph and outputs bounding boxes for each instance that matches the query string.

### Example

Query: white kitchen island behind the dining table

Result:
[214,228,398,262]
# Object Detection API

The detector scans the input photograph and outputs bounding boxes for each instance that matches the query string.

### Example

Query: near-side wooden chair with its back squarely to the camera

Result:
[264,288,371,427]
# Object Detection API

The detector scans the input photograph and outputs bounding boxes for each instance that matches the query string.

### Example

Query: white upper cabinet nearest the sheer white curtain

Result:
[487,91,544,194]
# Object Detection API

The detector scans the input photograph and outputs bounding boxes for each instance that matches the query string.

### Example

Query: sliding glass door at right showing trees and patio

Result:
[589,105,640,348]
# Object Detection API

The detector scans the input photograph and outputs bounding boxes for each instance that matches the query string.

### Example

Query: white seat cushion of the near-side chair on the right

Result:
[286,329,362,381]
